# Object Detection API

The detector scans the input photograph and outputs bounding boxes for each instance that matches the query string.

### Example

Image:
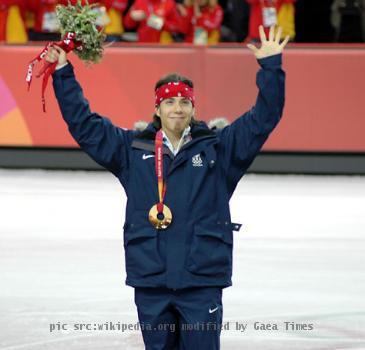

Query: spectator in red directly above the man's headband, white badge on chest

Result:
[124,0,182,44]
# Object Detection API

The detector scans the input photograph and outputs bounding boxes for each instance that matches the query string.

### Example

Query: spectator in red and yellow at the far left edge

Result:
[0,0,28,44]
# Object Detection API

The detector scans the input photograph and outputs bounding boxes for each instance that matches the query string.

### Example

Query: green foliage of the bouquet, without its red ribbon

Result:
[56,0,105,64]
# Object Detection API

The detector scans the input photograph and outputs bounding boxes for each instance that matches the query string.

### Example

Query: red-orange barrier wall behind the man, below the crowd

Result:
[0,46,365,152]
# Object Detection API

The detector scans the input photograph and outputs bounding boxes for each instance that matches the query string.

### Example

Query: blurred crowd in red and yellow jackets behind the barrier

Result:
[0,0,365,45]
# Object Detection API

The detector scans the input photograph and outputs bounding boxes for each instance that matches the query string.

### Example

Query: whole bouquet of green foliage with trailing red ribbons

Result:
[26,0,105,112]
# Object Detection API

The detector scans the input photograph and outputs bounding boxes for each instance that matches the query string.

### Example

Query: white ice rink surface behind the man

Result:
[0,170,365,350]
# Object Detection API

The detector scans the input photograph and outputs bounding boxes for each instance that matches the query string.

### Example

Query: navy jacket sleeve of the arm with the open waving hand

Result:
[218,54,285,192]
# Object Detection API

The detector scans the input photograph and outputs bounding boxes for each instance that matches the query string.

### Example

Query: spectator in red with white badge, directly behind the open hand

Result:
[246,0,295,41]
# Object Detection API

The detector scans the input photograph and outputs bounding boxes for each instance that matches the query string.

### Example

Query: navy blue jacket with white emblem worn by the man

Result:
[53,55,285,289]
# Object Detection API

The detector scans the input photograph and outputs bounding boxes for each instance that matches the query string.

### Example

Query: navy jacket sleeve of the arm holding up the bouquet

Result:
[53,63,133,176]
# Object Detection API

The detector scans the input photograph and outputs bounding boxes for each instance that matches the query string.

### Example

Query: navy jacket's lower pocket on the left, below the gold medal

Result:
[124,224,165,278]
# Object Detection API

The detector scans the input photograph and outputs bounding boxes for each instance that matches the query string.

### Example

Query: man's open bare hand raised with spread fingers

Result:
[247,26,289,59]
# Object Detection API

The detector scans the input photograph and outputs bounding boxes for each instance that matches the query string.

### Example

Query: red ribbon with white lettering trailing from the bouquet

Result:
[25,32,81,112]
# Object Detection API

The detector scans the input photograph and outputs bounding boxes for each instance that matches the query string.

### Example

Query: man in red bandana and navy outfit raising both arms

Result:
[46,27,289,350]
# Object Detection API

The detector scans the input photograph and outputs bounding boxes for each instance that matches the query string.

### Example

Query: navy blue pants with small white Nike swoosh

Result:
[134,287,223,350]
